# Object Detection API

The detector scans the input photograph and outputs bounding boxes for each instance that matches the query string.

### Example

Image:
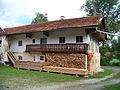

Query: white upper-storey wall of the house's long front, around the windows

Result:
[8,30,89,52]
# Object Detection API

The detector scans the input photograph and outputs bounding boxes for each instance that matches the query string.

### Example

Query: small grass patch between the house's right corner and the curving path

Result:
[90,69,112,78]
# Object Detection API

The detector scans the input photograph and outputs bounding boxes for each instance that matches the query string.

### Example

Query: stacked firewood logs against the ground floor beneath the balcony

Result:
[46,53,85,69]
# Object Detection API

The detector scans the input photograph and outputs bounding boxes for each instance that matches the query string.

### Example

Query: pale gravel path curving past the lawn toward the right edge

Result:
[25,67,120,90]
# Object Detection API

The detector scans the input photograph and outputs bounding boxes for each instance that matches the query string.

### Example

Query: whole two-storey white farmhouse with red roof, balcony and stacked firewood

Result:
[0,16,106,75]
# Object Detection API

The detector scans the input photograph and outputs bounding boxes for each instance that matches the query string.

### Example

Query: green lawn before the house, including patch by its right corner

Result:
[0,66,112,90]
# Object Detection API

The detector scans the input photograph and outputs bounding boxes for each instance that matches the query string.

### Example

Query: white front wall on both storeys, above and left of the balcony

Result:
[7,29,90,61]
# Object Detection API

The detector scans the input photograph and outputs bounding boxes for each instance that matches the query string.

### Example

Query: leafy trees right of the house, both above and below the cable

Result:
[81,0,120,65]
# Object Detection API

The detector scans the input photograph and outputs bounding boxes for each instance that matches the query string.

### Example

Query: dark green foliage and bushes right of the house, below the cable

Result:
[100,37,120,66]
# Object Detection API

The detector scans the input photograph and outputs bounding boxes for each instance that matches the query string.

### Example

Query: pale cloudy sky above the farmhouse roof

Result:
[0,0,86,28]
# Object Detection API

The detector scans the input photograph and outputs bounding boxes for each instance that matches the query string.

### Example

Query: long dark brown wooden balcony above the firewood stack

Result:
[26,43,88,54]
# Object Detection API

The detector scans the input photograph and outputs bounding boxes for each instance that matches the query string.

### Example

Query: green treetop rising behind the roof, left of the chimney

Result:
[31,12,48,23]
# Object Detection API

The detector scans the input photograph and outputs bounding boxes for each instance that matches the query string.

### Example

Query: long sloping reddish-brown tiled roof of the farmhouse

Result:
[4,16,103,34]
